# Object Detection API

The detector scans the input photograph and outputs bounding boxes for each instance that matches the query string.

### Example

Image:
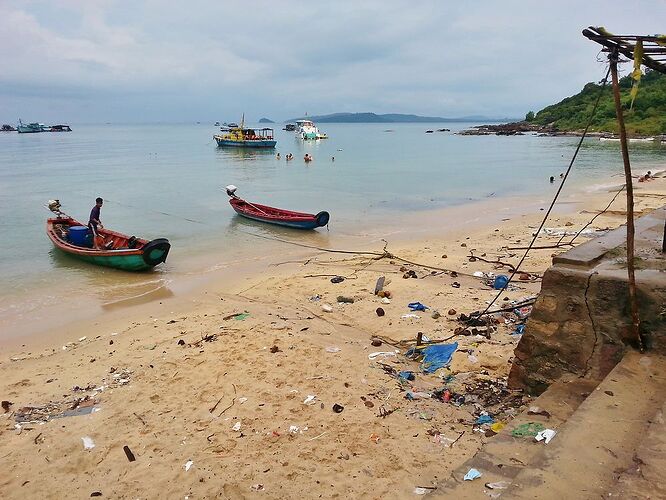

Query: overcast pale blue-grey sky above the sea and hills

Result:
[0,0,666,123]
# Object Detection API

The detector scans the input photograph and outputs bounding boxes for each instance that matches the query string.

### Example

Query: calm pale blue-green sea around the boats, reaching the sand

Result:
[0,123,666,340]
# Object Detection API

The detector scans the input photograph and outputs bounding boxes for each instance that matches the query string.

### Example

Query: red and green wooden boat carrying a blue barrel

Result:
[46,211,171,271]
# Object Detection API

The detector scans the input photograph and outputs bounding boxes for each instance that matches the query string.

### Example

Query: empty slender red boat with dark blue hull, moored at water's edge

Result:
[227,186,330,229]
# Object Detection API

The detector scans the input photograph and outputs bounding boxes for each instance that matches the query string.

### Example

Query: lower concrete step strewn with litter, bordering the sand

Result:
[428,379,599,499]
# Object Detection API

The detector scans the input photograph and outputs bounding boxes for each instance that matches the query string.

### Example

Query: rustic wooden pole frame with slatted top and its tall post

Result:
[583,26,666,352]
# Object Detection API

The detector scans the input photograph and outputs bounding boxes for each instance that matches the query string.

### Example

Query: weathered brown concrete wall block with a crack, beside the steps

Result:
[509,208,666,394]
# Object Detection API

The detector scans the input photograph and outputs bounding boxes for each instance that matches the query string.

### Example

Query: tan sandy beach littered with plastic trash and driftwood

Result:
[0,174,666,499]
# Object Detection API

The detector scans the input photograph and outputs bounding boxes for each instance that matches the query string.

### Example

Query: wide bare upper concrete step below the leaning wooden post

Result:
[504,351,666,500]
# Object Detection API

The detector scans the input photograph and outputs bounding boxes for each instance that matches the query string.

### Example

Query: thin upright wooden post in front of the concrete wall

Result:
[608,49,644,352]
